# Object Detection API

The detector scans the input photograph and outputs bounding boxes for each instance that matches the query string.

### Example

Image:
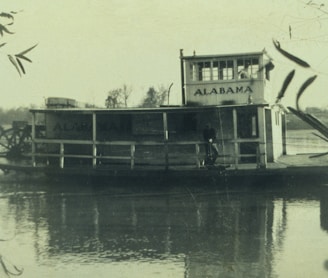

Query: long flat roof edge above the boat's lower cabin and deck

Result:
[30,103,268,114]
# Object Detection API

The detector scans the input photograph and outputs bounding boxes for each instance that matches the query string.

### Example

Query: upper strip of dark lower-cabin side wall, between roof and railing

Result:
[45,110,226,141]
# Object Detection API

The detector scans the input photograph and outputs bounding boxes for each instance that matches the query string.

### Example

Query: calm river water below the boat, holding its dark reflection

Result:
[0,177,328,277]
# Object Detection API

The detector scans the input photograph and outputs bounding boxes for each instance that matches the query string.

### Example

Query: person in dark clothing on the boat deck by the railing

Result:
[203,123,219,165]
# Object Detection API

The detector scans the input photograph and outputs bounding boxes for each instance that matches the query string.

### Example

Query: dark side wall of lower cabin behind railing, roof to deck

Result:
[45,109,233,165]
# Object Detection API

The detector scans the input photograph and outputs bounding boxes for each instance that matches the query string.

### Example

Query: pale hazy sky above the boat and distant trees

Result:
[0,0,328,108]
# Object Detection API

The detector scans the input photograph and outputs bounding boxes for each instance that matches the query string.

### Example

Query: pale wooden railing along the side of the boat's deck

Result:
[29,138,266,170]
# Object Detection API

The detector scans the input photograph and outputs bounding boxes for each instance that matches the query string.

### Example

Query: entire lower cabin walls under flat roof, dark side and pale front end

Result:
[40,105,276,165]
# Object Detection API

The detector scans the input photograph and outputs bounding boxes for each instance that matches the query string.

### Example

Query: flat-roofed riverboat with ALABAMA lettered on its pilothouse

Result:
[0,50,328,182]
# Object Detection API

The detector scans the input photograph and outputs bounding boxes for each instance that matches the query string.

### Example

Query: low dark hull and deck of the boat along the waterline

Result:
[0,154,328,181]
